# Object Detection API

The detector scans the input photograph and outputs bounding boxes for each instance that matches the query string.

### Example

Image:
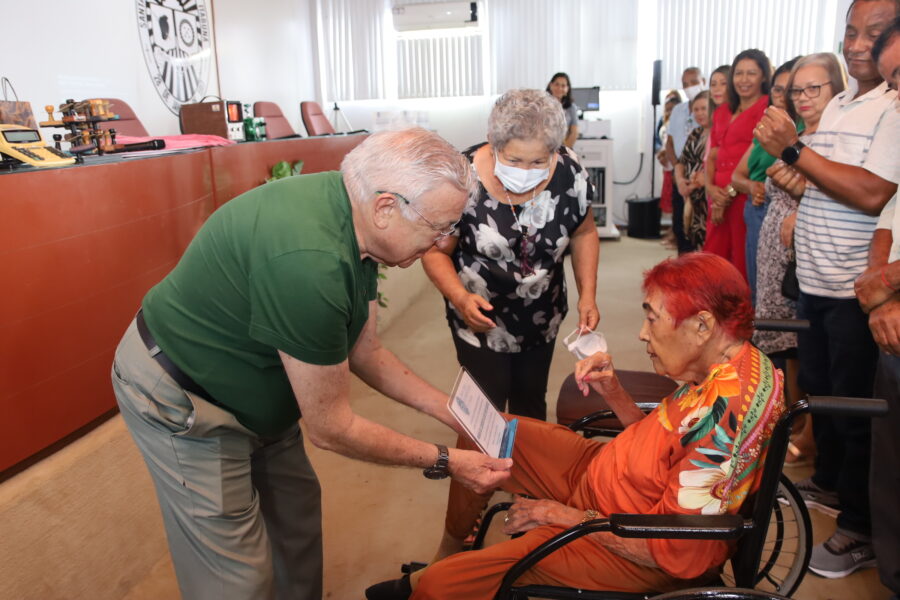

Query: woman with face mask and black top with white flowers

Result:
[422,90,600,419]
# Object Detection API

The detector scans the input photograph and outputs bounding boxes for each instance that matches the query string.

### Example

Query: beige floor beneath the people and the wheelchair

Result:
[0,238,889,600]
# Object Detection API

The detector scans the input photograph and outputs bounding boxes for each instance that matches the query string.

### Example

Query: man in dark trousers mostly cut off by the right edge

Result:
[855,18,900,600]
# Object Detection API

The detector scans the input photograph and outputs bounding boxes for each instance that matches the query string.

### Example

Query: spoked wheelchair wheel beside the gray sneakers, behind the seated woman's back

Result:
[722,475,812,598]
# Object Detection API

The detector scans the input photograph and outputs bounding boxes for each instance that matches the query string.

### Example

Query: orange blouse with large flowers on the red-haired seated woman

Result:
[587,342,784,579]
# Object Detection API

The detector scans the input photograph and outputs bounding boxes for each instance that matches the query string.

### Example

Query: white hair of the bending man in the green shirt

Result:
[341,126,474,220]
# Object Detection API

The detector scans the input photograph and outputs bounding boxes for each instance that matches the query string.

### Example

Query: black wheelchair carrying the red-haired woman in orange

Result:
[472,321,887,600]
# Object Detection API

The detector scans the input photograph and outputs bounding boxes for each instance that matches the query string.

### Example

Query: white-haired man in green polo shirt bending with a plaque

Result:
[112,129,511,600]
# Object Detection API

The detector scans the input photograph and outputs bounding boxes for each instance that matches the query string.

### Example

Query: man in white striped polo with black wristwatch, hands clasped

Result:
[756,0,900,577]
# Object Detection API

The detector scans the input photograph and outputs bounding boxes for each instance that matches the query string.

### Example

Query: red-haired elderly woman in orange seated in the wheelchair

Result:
[366,253,785,600]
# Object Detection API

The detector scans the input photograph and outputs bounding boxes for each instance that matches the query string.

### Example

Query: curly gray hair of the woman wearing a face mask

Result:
[487,90,567,152]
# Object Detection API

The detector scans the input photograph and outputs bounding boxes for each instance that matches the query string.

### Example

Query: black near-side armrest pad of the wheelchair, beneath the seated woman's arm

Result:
[609,514,744,540]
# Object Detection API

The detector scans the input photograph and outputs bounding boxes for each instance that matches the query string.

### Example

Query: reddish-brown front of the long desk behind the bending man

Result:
[0,135,366,473]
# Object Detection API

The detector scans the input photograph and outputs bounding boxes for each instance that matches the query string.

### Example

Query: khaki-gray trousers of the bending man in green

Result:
[112,321,322,600]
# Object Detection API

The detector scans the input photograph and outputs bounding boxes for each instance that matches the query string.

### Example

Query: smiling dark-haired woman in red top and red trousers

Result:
[703,49,772,279]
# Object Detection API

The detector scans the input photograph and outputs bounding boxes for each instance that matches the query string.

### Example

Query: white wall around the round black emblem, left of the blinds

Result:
[0,0,316,139]
